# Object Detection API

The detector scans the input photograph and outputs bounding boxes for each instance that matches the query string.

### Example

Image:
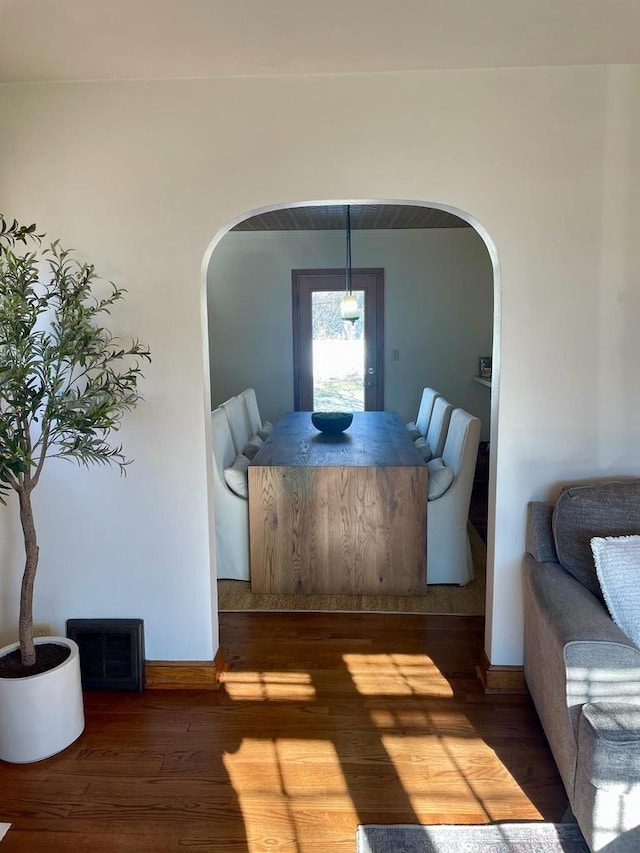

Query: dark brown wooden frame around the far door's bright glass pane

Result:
[291,267,384,411]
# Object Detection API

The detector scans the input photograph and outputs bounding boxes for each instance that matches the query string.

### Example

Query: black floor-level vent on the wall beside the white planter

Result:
[67,619,144,692]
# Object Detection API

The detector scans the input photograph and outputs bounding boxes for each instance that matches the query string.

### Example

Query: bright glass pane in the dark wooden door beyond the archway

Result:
[311,290,364,412]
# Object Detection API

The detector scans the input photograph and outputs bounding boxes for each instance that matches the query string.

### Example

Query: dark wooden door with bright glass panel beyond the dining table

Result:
[292,269,384,412]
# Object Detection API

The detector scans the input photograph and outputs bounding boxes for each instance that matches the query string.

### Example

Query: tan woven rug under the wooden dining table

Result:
[218,524,487,616]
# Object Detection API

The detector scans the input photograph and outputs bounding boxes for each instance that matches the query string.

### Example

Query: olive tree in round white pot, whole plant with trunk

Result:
[0,215,150,762]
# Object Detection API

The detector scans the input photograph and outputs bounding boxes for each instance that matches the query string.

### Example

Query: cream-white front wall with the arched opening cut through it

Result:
[0,66,640,664]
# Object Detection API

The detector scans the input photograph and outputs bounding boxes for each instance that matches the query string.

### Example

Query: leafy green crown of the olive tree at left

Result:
[0,216,151,494]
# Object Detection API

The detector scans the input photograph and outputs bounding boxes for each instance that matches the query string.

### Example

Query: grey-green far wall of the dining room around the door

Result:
[208,228,493,440]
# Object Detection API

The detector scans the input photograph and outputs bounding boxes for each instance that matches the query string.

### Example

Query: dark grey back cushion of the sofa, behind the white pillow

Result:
[552,480,640,601]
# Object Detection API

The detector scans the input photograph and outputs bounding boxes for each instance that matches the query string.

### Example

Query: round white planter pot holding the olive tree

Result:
[0,637,84,764]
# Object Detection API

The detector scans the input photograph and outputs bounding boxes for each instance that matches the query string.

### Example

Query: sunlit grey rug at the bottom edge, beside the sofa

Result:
[357,822,589,853]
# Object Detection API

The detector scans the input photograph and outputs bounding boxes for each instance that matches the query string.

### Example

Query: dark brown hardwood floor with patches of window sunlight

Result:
[0,612,566,853]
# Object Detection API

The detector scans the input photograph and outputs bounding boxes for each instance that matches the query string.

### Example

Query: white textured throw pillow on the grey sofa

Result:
[591,536,640,646]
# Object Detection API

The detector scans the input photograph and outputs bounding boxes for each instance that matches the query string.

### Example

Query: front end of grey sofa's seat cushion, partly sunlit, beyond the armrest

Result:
[578,700,640,794]
